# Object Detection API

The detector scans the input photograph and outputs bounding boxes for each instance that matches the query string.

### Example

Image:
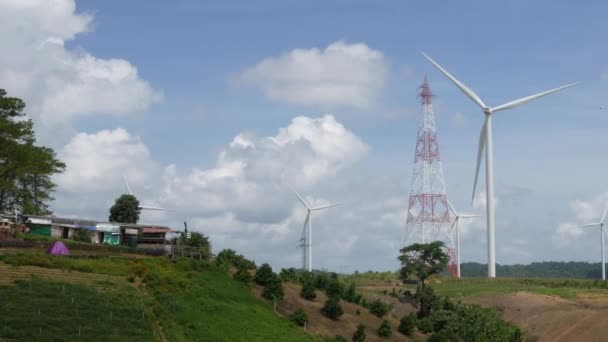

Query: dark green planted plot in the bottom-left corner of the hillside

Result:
[0,278,160,341]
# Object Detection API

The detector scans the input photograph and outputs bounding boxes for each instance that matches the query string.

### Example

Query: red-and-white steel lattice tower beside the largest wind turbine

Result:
[406,76,456,275]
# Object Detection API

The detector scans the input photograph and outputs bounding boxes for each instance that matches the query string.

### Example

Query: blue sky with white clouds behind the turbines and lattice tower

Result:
[0,0,608,271]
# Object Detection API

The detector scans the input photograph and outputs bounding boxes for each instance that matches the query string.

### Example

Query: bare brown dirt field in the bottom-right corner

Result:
[464,292,608,341]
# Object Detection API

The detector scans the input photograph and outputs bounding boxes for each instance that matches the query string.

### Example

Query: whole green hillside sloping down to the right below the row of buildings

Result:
[0,254,314,341]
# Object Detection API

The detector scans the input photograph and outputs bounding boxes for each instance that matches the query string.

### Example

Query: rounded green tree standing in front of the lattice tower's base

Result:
[398,241,449,288]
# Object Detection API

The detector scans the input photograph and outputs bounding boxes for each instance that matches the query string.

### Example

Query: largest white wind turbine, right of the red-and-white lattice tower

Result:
[422,53,578,278]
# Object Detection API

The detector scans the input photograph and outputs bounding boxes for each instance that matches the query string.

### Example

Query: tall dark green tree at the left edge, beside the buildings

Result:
[0,89,65,215]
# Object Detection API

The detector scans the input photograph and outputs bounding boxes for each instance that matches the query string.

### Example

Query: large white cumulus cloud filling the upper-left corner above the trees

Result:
[0,0,162,127]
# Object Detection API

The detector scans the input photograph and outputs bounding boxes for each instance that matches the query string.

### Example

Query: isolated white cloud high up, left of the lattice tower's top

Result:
[239,41,388,108]
